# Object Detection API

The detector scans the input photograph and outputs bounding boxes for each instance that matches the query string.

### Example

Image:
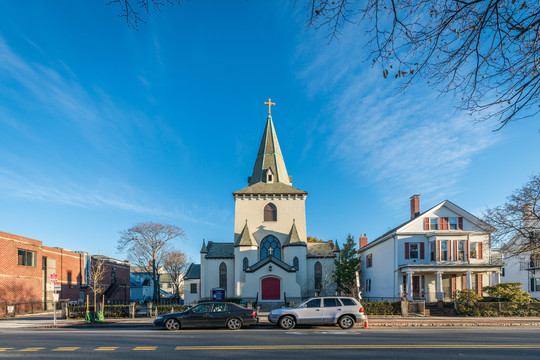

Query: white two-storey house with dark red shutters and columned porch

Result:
[360,195,501,302]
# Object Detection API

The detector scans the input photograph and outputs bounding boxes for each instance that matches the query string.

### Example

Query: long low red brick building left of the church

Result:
[0,231,130,303]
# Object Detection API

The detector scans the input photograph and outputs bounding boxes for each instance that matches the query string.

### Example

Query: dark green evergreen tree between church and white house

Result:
[334,234,360,297]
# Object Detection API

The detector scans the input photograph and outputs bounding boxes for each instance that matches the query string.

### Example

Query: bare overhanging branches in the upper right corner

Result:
[309,0,540,130]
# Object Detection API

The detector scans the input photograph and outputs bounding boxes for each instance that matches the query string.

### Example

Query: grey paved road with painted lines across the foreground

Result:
[0,327,540,360]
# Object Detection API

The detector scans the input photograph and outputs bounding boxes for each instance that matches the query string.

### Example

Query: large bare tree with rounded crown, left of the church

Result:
[118,221,185,301]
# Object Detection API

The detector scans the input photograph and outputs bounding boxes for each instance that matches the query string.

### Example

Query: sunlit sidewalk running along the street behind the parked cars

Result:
[0,312,540,329]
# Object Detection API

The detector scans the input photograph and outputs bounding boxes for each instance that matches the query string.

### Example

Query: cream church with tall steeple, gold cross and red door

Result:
[184,105,339,304]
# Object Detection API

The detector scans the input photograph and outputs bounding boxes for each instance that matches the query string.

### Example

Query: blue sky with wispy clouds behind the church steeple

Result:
[0,0,540,260]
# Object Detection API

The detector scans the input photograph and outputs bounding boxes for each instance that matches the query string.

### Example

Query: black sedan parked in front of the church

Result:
[154,302,259,330]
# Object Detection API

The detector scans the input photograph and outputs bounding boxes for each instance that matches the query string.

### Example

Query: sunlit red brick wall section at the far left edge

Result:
[0,231,43,302]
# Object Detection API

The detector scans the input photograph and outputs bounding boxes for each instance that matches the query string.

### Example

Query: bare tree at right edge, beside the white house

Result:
[484,174,540,256]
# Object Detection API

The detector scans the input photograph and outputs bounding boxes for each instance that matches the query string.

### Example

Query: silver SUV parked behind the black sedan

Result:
[268,296,366,329]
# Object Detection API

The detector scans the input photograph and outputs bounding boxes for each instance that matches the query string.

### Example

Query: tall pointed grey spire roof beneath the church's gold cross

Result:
[248,113,292,186]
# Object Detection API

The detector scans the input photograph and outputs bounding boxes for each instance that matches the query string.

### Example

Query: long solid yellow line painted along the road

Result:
[175,344,540,350]
